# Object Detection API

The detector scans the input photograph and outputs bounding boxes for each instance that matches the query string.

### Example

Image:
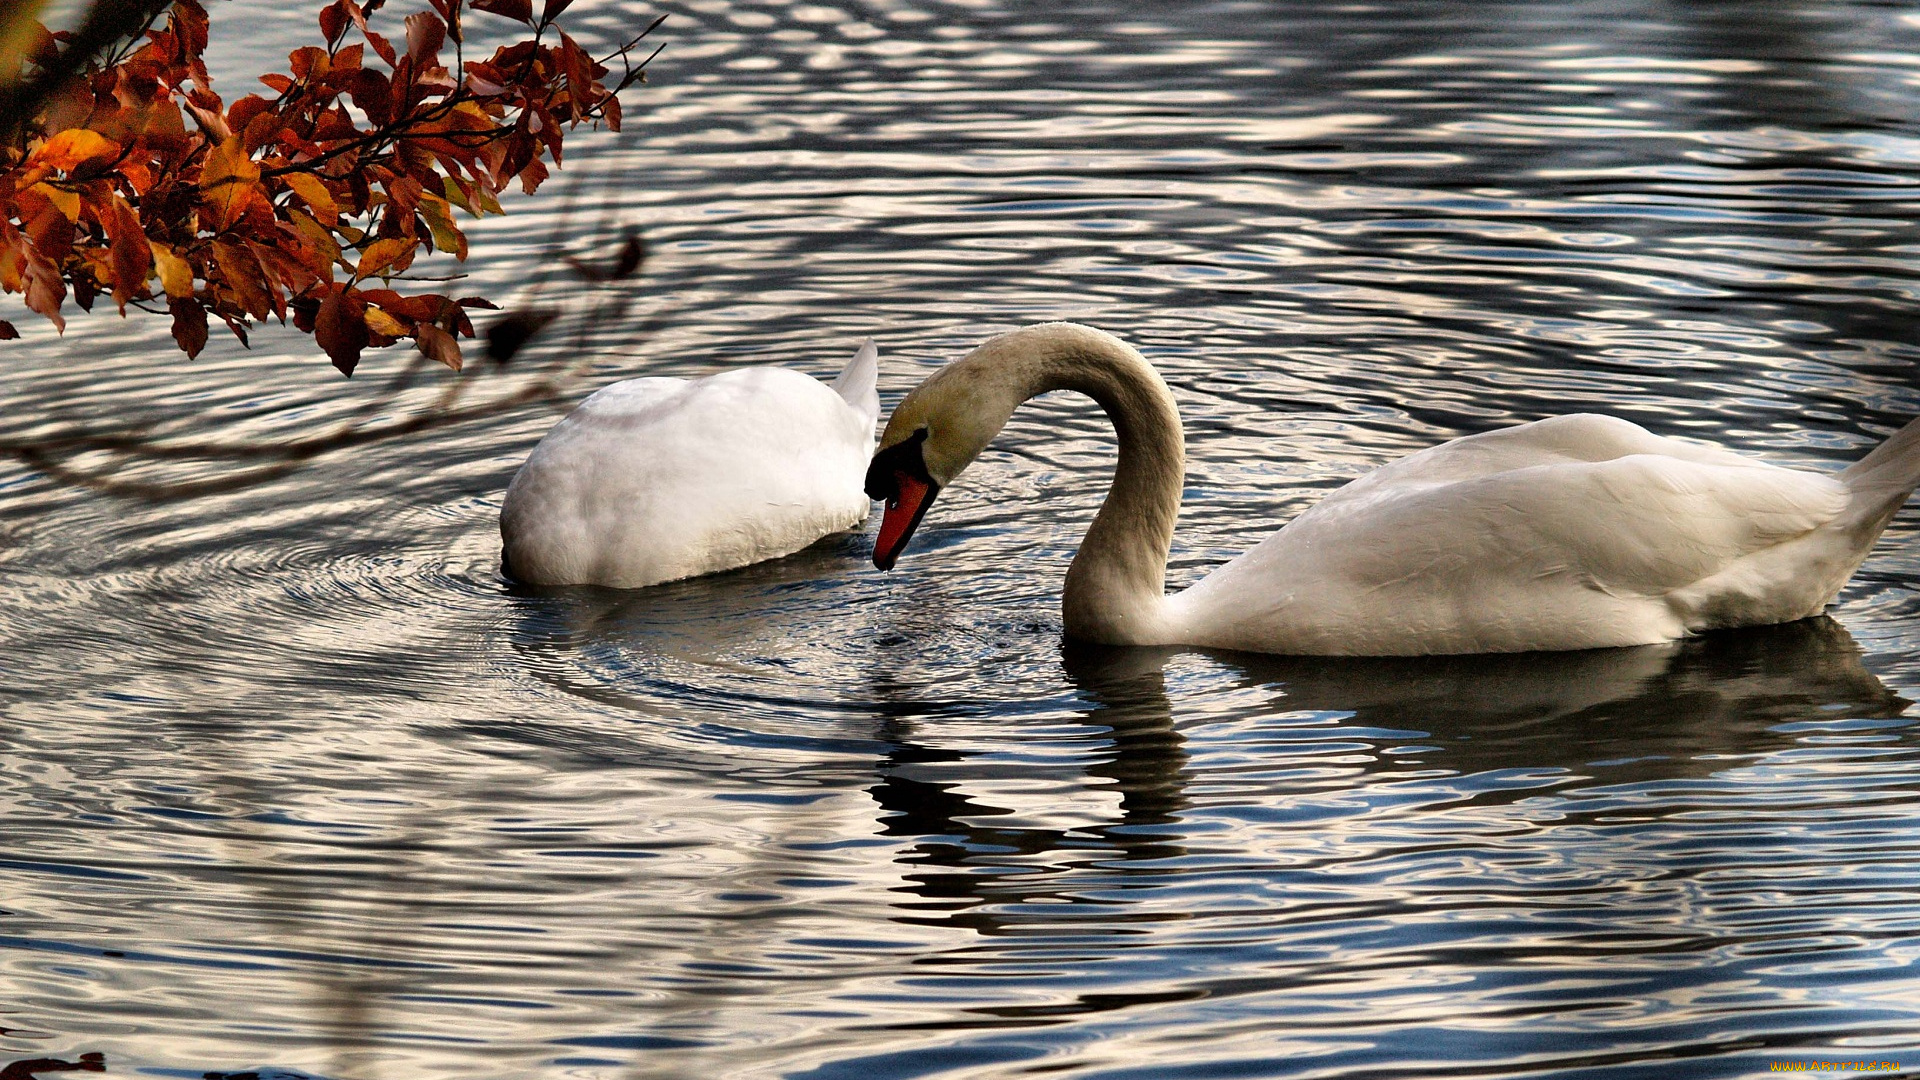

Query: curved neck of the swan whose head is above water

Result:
[956,323,1187,646]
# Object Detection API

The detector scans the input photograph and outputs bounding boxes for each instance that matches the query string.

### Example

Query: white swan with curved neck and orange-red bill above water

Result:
[866,323,1920,655]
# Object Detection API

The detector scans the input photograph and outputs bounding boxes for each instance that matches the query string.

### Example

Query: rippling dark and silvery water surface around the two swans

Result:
[0,0,1920,1080]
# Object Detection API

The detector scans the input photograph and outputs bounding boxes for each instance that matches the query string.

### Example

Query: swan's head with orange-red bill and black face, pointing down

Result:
[866,340,1025,571]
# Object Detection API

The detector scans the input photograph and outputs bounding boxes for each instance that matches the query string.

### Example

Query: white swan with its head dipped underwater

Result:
[499,342,879,588]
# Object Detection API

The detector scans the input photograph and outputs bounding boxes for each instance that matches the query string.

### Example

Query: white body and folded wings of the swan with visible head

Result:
[1175,417,1847,653]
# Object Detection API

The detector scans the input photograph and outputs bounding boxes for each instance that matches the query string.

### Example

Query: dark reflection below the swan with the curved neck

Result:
[872,617,1908,920]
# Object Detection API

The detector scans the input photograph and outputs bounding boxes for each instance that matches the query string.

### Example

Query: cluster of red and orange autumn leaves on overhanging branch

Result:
[0,0,657,373]
